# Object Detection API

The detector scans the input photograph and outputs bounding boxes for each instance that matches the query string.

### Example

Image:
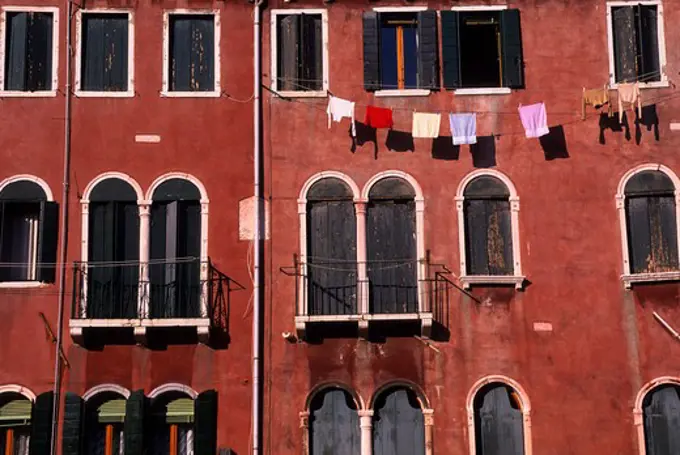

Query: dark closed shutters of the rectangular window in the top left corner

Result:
[2,11,56,92]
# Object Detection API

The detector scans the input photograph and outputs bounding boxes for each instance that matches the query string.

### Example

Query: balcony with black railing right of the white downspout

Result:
[281,256,457,338]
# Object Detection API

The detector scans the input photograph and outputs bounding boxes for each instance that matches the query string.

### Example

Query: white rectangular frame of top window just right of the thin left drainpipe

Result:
[74,8,135,98]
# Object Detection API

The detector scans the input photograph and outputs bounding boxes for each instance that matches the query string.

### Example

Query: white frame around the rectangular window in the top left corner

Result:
[0,6,60,98]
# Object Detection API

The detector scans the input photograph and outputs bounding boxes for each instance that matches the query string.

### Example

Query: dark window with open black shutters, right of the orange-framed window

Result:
[442,9,524,89]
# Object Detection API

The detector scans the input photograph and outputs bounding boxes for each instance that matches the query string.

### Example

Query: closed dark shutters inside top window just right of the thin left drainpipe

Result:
[77,12,131,92]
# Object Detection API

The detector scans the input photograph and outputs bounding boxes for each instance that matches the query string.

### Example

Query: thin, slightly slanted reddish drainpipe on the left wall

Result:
[50,0,73,455]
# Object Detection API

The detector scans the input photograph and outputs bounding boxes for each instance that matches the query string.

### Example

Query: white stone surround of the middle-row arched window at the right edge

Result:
[616,163,680,289]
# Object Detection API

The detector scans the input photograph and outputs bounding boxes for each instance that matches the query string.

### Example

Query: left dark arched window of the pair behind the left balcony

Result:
[87,177,139,319]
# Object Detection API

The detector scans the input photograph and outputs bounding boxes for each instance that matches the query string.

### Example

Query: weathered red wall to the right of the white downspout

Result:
[264,0,680,455]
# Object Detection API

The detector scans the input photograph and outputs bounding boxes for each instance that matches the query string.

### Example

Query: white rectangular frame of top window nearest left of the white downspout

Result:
[161,8,222,98]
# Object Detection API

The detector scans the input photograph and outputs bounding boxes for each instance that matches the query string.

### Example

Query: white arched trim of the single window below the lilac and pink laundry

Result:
[455,169,526,289]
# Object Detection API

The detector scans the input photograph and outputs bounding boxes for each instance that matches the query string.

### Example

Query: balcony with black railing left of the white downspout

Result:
[69,258,244,342]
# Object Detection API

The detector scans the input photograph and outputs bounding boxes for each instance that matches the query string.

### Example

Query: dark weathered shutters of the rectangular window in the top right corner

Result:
[610,4,663,83]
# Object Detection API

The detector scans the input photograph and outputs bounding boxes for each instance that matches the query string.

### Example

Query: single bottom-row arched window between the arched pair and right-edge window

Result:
[473,382,524,455]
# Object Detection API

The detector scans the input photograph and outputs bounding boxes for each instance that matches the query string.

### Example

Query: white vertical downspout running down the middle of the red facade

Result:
[252,0,264,455]
